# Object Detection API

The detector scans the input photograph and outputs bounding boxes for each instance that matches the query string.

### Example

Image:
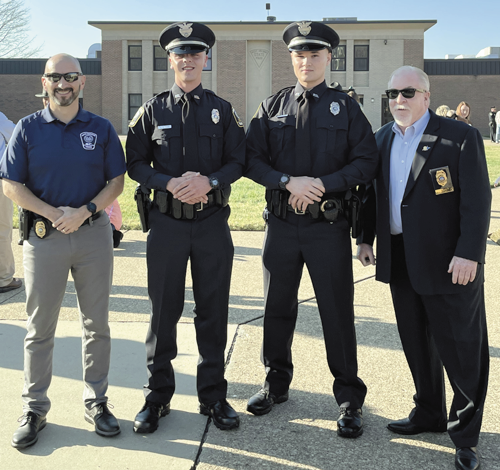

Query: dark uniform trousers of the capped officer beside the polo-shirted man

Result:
[144,206,234,404]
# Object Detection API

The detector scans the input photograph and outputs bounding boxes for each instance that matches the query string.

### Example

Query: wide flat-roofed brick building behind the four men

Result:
[0,18,500,135]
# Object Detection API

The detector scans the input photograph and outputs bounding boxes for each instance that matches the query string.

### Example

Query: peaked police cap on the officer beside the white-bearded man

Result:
[283,21,340,52]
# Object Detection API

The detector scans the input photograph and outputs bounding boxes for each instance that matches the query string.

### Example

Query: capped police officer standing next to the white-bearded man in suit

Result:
[245,21,378,437]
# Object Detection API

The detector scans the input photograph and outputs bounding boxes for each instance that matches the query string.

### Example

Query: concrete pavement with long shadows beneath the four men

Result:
[0,189,500,470]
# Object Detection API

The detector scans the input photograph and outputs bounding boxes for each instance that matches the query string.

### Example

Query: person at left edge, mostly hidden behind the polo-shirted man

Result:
[0,113,23,294]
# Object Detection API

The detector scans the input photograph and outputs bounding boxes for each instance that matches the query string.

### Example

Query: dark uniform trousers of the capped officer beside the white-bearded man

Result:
[262,212,366,408]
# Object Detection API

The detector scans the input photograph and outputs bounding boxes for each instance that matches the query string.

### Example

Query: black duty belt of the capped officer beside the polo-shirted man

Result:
[154,189,229,220]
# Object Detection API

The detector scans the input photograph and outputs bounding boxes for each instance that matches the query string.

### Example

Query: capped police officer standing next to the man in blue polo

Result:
[126,22,245,433]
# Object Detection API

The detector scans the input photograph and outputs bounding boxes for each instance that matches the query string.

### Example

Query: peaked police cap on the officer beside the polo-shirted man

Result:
[159,22,215,54]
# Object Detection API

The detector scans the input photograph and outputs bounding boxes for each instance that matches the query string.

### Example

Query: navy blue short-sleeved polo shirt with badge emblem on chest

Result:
[0,106,126,208]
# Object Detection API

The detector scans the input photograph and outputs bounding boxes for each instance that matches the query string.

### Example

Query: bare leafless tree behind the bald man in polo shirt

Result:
[0,0,42,59]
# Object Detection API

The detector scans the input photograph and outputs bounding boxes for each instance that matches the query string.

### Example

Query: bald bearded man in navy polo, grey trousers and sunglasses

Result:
[0,54,126,449]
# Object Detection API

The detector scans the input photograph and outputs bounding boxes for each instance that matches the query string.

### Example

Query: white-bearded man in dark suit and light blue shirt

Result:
[358,66,491,469]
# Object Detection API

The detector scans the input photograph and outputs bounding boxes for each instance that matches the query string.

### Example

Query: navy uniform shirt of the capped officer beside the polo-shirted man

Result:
[126,84,245,191]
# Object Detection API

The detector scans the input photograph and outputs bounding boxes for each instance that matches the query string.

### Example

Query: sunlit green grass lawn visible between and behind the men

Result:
[7,139,500,230]
